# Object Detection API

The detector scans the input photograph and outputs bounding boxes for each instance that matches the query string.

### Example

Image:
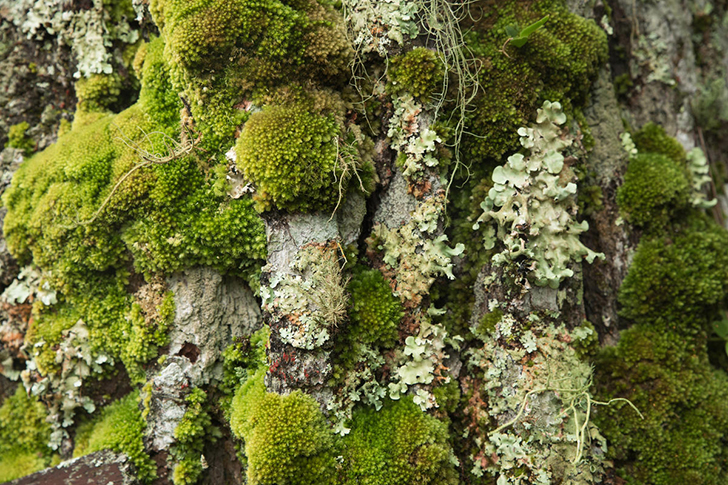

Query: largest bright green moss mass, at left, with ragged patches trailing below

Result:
[4,35,265,390]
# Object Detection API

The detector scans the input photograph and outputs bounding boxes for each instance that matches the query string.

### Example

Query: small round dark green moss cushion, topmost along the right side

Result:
[617,153,690,229]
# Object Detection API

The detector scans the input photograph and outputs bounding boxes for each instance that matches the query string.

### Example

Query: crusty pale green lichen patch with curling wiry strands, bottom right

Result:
[469,318,606,485]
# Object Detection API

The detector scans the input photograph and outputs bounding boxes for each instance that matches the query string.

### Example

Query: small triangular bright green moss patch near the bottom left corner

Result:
[73,392,156,483]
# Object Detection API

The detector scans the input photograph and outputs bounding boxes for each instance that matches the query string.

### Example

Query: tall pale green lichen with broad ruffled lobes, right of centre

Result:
[474,101,604,288]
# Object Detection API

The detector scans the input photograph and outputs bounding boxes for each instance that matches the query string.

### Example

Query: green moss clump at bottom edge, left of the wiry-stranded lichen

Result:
[341,398,458,485]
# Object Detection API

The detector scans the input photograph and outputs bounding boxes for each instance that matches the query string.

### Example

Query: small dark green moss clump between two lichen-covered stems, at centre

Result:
[349,269,404,348]
